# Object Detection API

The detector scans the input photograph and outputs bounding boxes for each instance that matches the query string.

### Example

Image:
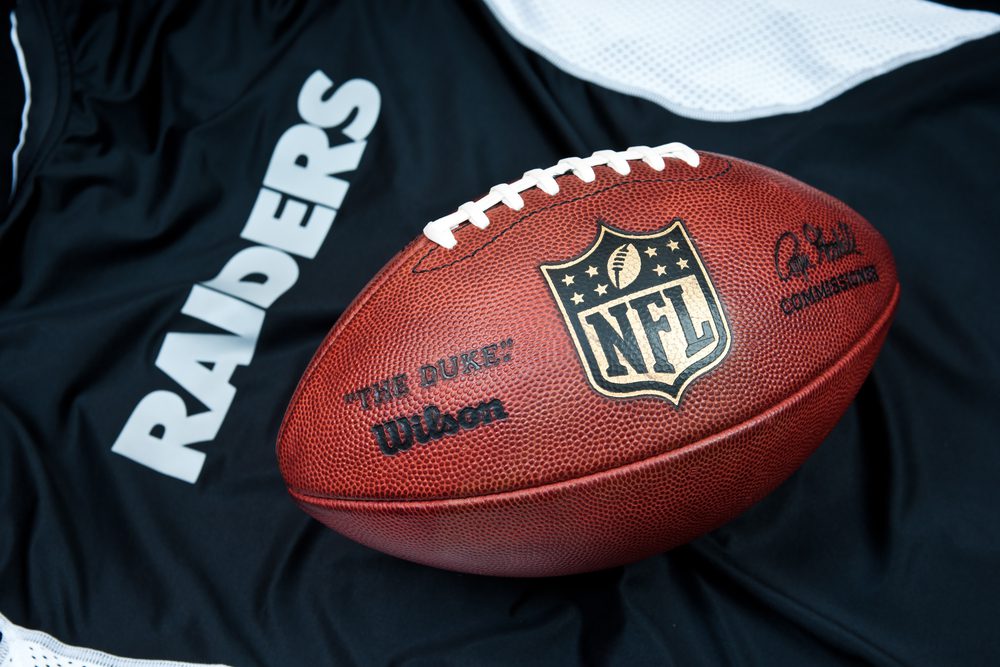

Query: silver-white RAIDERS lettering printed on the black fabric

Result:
[111,70,381,484]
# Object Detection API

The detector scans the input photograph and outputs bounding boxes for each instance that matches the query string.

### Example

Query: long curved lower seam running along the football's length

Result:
[287,281,900,509]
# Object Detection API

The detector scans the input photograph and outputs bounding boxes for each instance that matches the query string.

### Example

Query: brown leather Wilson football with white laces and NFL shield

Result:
[277,143,899,576]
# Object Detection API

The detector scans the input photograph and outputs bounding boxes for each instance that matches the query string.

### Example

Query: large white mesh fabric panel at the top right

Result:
[486,0,1000,121]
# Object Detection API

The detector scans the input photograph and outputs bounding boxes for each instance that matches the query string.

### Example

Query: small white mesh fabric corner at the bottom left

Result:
[0,614,225,667]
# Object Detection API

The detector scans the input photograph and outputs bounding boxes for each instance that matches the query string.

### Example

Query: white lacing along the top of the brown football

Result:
[424,141,700,250]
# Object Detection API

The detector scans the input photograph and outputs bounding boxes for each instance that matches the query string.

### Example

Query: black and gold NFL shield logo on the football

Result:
[541,218,731,405]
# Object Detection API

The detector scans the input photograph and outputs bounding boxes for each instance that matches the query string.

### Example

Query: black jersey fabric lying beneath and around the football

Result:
[0,1,1000,665]
